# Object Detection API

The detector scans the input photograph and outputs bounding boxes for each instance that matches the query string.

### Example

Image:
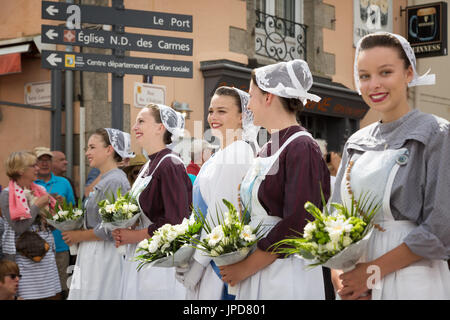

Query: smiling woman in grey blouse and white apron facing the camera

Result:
[331,33,450,300]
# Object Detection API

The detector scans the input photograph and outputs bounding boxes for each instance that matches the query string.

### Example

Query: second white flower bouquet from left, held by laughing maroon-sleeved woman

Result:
[98,188,141,255]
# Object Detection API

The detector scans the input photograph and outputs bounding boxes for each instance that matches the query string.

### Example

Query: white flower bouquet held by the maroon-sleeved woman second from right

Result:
[193,199,263,294]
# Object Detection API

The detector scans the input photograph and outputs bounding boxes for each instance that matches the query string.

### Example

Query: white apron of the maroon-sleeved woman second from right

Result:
[236,131,325,300]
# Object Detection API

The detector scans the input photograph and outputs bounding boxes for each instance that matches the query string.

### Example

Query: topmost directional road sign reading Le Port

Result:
[42,1,192,32]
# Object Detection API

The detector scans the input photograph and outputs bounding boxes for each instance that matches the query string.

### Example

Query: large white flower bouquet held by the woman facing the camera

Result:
[273,193,380,270]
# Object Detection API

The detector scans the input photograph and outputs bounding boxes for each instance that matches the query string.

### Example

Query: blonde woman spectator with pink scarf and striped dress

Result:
[0,151,61,300]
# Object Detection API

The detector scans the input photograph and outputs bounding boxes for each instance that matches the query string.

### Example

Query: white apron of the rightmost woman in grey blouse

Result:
[341,148,450,300]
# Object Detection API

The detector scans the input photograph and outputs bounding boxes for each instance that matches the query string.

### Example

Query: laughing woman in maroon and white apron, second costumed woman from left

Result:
[113,104,192,300]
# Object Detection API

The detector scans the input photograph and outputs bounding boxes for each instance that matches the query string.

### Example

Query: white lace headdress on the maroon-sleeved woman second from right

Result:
[255,59,321,104]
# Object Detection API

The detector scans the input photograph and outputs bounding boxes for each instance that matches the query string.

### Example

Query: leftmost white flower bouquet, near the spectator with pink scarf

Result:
[46,199,84,255]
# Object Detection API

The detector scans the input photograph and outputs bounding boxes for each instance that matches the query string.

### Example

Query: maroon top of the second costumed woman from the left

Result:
[139,148,192,236]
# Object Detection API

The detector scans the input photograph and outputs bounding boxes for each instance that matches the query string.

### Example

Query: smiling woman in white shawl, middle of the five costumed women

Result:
[177,86,258,300]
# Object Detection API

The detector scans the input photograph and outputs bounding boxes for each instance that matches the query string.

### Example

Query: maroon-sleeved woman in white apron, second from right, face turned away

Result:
[220,60,330,299]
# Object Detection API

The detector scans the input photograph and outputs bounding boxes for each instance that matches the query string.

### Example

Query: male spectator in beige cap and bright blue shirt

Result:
[34,147,75,298]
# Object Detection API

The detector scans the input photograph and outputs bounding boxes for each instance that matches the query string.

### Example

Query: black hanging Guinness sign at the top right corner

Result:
[406,2,447,58]
